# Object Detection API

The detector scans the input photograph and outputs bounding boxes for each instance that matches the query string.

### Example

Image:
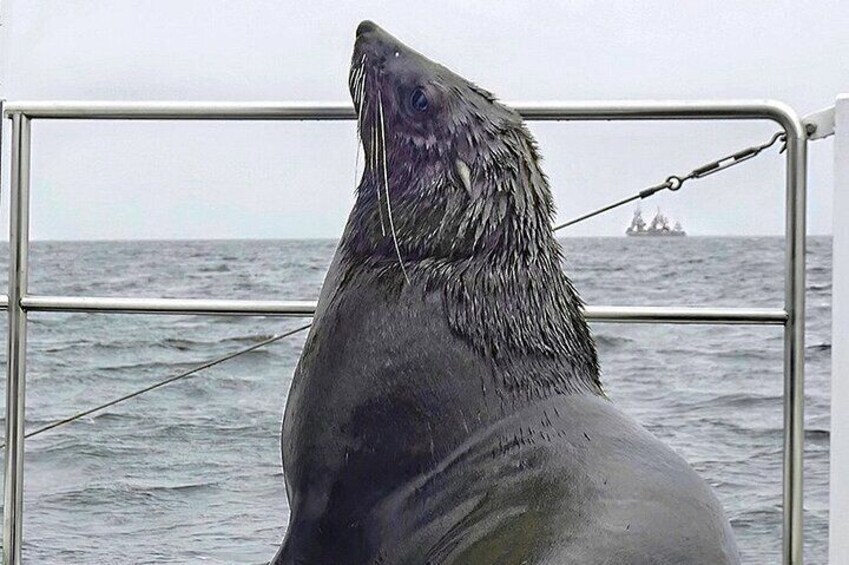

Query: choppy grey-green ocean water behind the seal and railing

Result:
[0,237,831,564]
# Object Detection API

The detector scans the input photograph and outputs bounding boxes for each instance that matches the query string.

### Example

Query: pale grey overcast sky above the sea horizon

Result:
[0,0,849,239]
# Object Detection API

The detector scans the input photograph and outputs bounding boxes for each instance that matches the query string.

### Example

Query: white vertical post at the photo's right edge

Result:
[828,95,849,563]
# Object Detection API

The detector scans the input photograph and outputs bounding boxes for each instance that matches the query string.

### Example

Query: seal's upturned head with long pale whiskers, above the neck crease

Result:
[349,21,553,261]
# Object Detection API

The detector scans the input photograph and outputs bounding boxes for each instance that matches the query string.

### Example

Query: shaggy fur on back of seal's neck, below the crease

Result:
[437,249,601,396]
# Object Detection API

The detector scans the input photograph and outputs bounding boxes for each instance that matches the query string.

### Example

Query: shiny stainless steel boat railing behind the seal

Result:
[0,101,807,565]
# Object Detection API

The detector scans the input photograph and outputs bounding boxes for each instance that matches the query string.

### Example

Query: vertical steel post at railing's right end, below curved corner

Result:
[783,112,808,565]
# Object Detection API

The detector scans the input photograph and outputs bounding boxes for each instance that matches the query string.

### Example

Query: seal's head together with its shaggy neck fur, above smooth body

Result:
[342,21,600,390]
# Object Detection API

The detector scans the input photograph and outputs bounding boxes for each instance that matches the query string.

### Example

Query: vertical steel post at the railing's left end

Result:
[3,113,31,565]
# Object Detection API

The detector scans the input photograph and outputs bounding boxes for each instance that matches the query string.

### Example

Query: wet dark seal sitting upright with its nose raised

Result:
[272,21,739,565]
